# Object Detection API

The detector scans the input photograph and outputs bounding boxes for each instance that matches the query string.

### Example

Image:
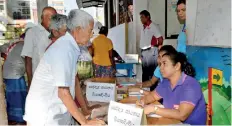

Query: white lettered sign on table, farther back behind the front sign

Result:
[86,82,116,102]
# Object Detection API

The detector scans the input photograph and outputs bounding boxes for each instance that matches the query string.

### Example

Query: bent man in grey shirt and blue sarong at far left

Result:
[0,33,27,125]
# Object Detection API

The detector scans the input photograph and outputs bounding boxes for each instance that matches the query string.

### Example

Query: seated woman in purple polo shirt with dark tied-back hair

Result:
[137,52,206,125]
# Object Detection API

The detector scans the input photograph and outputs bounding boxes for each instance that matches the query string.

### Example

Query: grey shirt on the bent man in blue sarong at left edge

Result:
[3,41,25,79]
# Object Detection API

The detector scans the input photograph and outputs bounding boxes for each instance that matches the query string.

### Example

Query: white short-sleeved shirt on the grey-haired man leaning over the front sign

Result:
[24,32,80,125]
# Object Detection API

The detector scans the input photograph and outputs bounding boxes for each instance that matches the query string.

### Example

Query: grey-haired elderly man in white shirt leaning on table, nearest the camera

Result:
[24,9,104,125]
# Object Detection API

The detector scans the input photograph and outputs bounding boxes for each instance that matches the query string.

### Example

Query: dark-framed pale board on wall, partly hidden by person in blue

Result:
[165,0,183,39]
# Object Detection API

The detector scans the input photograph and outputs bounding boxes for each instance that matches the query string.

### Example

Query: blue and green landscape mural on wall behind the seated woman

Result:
[187,46,232,125]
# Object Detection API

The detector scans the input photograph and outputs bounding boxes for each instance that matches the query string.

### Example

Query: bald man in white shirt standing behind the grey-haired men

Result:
[21,7,57,89]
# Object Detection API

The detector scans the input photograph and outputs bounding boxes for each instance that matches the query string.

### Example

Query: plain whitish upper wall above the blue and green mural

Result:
[186,0,232,47]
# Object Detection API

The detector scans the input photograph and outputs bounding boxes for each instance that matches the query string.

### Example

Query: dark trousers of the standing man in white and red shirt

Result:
[141,47,158,89]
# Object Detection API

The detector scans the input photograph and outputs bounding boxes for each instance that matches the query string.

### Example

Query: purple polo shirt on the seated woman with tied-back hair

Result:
[155,73,207,125]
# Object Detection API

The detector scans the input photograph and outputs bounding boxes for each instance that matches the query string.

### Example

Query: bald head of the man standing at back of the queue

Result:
[41,7,57,29]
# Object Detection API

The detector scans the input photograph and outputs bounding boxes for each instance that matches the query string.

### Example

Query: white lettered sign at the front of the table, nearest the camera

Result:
[108,101,143,126]
